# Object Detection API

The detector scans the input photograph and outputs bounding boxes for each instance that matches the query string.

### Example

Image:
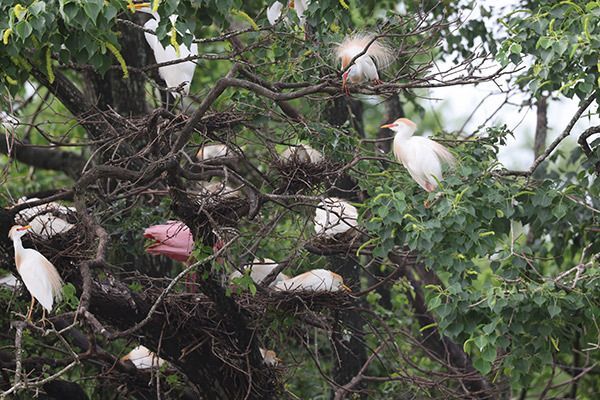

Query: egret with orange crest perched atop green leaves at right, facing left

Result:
[382,118,455,192]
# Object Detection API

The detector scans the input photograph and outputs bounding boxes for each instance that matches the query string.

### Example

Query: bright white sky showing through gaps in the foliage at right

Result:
[425,0,600,170]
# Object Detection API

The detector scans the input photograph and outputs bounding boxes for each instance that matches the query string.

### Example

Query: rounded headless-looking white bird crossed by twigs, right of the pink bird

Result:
[314,197,358,237]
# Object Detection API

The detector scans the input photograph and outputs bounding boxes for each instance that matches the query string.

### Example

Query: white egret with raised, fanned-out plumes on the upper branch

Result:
[336,34,393,94]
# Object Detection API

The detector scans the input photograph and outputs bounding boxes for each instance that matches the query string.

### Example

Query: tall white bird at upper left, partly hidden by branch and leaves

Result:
[134,3,198,97]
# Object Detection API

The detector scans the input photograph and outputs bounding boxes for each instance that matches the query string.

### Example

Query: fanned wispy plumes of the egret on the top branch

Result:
[335,33,394,69]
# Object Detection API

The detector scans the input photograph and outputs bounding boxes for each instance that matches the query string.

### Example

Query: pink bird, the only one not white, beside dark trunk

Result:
[144,221,194,262]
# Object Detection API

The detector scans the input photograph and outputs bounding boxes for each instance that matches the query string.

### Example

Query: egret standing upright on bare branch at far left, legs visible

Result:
[8,225,63,321]
